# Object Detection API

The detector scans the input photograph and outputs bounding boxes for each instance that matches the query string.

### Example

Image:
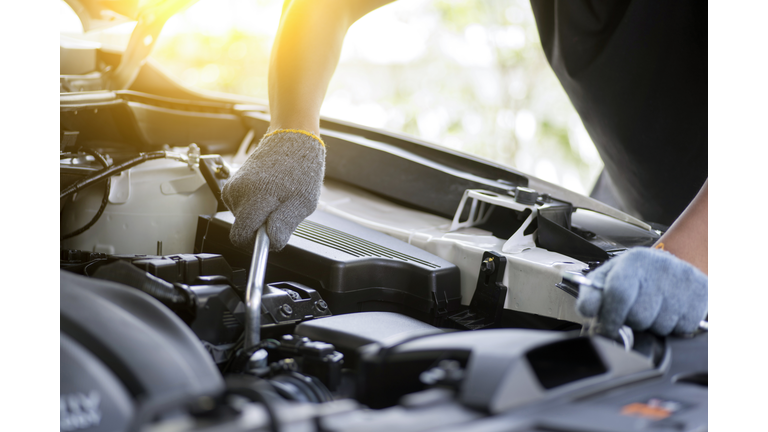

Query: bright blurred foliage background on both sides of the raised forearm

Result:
[153,0,602,193]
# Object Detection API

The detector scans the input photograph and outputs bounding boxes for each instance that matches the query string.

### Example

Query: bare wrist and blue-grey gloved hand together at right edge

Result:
[576,180,709,336]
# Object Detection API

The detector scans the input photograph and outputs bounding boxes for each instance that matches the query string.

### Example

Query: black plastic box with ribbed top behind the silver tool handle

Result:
[195,211,461,325]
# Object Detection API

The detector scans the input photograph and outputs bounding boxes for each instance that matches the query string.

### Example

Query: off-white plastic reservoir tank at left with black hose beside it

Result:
[61,154,217,255]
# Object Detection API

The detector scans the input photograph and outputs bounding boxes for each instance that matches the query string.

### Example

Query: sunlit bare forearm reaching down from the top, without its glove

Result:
[269,0,394,135]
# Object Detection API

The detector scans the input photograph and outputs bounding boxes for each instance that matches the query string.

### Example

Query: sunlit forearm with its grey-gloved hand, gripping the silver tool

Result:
[221,0,392,250]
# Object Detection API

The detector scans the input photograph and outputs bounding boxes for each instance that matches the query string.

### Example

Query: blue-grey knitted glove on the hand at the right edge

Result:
[576,247,708,336]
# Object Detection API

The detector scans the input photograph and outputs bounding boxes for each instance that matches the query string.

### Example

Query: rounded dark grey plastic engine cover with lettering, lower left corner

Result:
[60,271,224,420]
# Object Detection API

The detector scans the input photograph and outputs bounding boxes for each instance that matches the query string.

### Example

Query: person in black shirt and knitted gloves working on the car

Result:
[223,0,708,335]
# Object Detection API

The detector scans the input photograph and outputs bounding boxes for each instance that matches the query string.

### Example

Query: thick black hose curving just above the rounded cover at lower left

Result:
[93,261,197,324]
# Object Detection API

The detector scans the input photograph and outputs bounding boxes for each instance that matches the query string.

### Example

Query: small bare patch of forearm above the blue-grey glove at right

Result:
[657,179,709,274]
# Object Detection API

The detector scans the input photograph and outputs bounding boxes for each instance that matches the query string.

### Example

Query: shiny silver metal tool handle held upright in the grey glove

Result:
[244,226,269,350]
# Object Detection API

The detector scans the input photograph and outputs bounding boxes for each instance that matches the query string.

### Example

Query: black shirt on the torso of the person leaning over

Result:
[531,0,708,225]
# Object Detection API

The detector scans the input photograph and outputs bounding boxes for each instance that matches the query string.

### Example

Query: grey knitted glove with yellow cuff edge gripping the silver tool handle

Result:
[221,129,325,251]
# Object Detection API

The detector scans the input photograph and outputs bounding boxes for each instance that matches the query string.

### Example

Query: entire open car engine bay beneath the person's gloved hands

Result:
[60,86,708,431]
